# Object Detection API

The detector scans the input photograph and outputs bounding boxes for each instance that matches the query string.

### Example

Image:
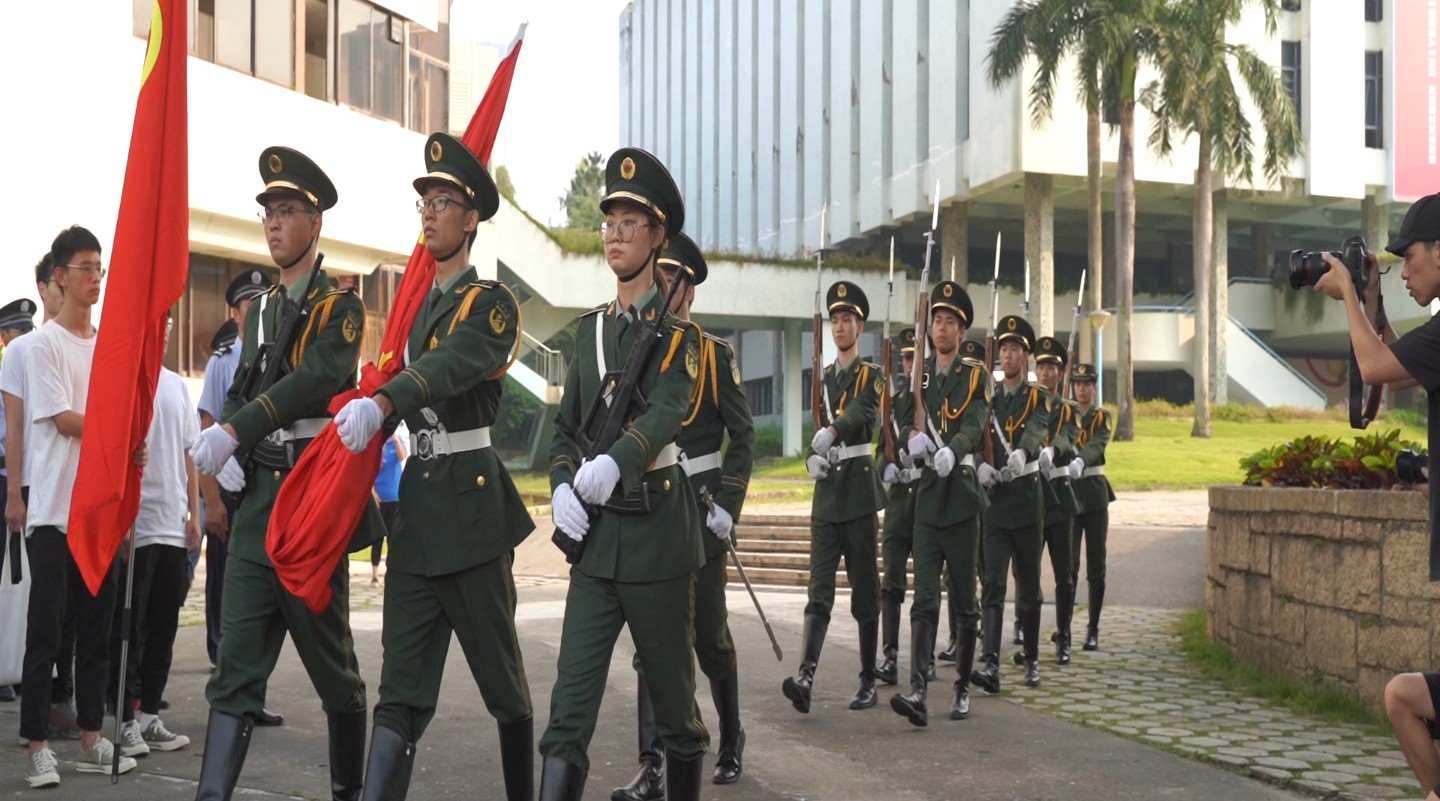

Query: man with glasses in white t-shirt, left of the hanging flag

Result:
[19,225,145,787]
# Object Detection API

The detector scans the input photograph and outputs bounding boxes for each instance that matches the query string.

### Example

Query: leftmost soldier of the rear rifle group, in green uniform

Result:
[780,281,886,713]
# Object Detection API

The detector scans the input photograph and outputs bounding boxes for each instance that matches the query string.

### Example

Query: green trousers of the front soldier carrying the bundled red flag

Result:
[374,553,531,742]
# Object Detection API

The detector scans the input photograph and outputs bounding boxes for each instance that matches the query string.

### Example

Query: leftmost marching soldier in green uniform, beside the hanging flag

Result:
[190,147,382,800]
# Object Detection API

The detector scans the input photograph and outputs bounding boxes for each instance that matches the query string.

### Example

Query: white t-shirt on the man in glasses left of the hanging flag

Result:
[24,320,95,533]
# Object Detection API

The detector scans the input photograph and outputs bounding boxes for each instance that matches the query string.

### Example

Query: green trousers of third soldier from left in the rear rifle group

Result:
[910,517,981,631]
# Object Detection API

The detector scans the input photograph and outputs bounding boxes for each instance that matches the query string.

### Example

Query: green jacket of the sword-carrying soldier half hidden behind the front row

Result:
[677,334,755,560]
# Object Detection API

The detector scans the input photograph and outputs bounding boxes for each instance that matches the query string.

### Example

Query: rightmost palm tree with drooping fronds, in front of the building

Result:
[1145,0,1300,437]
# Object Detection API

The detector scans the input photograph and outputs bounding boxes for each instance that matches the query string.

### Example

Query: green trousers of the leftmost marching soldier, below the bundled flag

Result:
[204,555,366,717]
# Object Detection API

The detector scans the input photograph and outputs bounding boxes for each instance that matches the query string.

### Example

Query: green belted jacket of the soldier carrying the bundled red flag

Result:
[380,268,534,576]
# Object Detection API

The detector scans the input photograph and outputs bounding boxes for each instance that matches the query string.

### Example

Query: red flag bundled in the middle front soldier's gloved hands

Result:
[265,24,526,614]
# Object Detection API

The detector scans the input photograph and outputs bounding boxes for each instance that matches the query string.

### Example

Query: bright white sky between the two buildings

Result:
[451,0,628,225]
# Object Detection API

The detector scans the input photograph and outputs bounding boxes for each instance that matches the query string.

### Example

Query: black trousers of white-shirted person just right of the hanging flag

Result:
[107,545,189,720]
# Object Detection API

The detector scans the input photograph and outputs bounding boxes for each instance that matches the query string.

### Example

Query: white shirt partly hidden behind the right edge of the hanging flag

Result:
[135,367,200,547]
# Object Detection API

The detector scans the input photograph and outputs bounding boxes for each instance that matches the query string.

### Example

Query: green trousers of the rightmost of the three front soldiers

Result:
[540,568,710,771]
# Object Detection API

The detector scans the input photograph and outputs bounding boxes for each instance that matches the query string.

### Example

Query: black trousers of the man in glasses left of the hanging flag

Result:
[20,526,120,740]
